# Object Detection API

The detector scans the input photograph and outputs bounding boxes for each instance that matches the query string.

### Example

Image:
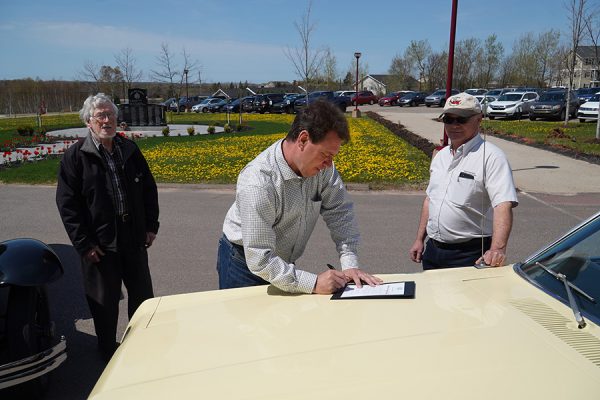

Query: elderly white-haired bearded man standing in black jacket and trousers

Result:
[56,93,159,360]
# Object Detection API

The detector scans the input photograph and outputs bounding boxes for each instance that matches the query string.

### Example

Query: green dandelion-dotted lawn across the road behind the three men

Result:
[0,114,430,188]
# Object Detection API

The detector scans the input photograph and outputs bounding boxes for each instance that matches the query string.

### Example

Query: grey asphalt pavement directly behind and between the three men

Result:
[0,185,600,400]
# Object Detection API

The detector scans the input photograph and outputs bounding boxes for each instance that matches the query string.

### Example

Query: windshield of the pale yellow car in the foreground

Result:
[515,213,600,323]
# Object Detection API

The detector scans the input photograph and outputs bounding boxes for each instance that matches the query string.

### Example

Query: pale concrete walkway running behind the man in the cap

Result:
[374,108,600,194]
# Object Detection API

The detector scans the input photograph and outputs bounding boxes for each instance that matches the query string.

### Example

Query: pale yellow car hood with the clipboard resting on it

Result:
[90,267,600,400]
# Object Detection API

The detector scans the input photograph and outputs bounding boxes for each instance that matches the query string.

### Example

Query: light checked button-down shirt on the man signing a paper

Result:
[223,140,360,293]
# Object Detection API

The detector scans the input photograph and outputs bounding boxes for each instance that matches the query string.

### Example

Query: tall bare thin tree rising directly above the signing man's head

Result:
[284,0,323,91]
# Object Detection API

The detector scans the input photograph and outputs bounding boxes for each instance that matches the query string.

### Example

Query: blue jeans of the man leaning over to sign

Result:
[217,235,269,289]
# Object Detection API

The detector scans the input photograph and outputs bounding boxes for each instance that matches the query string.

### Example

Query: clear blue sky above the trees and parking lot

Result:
[0,0,568,83]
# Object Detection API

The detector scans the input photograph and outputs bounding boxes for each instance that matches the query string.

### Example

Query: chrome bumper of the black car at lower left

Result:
[0,336,67,389]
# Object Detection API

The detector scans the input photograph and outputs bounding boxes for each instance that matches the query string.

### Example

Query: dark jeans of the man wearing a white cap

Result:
[421,237,492,269]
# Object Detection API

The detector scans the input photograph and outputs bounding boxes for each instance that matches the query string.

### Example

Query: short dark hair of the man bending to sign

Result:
[286,100,350,143]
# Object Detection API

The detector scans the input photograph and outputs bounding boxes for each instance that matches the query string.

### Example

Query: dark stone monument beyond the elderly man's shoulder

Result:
[118,88,167,127]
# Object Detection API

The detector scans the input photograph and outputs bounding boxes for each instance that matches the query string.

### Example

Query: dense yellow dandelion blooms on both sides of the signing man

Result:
[143,114,430,185]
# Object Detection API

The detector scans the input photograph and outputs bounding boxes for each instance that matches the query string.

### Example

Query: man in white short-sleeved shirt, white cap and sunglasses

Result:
[410,93,518,269]
